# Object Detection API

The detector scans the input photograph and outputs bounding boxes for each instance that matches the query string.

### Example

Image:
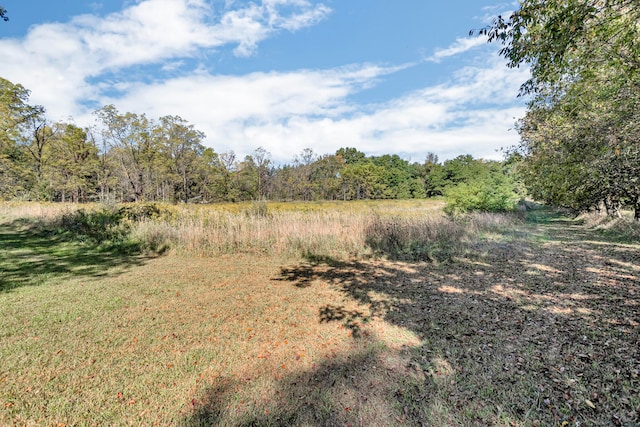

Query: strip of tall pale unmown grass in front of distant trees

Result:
[1,201,524,261]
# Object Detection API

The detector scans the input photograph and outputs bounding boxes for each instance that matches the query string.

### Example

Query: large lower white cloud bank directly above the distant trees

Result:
[91,49,527,163]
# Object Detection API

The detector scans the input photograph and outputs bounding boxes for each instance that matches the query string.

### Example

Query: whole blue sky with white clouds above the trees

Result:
[0,0,528,164]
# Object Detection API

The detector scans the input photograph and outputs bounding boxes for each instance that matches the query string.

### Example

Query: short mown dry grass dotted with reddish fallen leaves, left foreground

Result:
[0,252,419,425]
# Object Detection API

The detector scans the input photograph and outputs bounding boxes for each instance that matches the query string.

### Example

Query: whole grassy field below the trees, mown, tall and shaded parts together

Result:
[0,201,640,426]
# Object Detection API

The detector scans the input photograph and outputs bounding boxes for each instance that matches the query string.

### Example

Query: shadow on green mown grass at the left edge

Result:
[0,219,151,292]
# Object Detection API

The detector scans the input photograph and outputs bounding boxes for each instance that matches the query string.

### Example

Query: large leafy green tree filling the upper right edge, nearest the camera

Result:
[477,0,640,220]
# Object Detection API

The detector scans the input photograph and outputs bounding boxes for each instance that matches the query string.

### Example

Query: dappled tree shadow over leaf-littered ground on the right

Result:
[262,212,640,425]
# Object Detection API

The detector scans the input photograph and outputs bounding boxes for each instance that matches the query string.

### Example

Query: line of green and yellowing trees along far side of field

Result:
[0,78,513,206]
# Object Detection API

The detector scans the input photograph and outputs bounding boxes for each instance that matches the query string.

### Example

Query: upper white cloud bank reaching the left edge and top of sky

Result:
[0,0,330,117]
